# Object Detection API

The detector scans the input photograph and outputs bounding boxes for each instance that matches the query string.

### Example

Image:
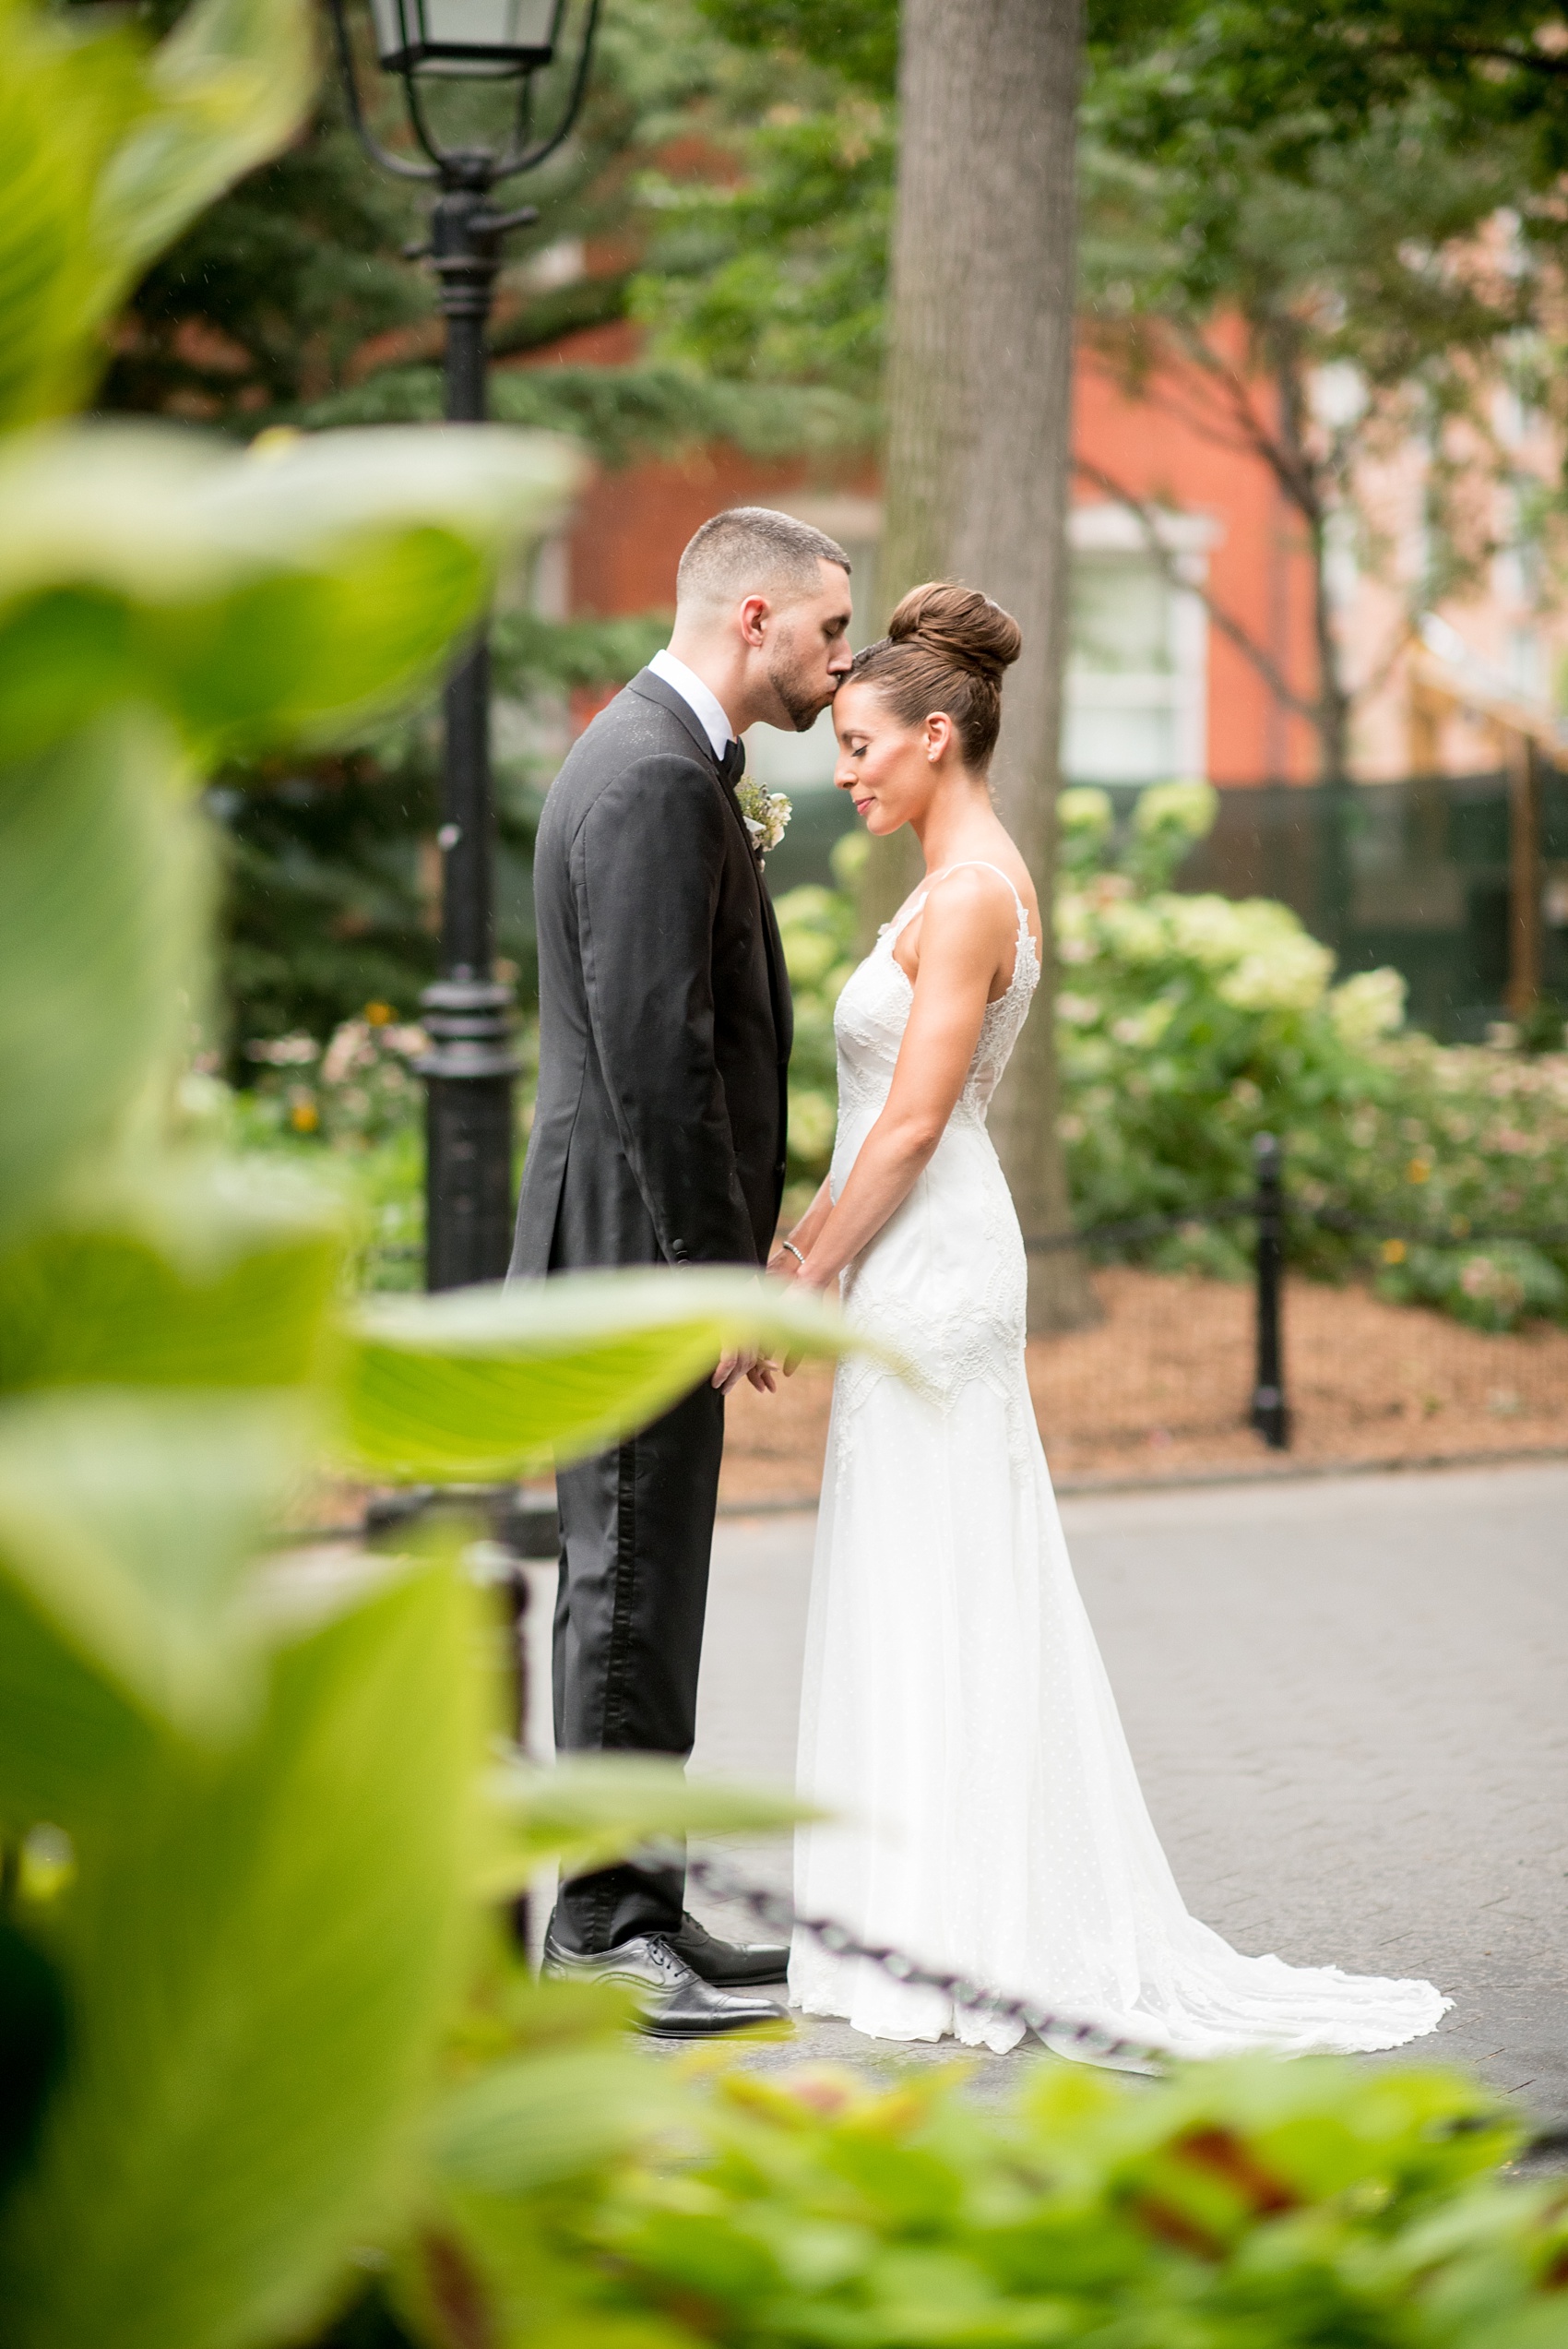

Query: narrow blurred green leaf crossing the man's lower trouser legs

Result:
[481,1755,822,1901]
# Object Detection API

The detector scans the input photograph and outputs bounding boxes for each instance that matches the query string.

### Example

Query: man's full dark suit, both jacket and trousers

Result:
[512,670,791,1950]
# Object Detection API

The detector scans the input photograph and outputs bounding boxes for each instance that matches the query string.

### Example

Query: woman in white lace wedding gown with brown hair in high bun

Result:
[772,585,1448,2056]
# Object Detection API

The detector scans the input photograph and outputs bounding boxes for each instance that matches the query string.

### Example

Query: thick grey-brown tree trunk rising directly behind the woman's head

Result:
[864,0,1096,1330]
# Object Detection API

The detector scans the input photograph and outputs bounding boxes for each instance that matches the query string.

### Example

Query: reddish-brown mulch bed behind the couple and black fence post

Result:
[720,1266,1568,1510]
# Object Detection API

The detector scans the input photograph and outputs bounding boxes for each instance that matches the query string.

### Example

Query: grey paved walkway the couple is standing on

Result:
[647,1463,1568,2124]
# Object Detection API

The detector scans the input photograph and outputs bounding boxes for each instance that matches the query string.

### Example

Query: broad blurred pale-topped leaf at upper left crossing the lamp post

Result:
[0,425,582,761]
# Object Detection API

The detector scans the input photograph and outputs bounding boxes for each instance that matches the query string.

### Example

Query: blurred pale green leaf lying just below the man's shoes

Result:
[430,2046,690,2194]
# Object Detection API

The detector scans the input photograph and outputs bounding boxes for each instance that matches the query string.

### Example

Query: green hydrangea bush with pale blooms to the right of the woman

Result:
[1056,784,1568,1330]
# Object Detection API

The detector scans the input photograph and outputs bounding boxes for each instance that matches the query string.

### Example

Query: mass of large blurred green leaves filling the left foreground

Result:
[0,0,838,2349]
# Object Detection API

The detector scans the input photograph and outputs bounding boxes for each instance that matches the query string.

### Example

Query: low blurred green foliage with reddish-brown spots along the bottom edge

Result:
[392,2062,1568,2349]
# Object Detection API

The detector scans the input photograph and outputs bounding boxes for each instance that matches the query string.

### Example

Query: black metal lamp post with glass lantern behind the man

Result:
[331,0,599,1290]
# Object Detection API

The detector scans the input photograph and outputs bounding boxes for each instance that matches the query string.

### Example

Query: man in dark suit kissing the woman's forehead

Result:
[512,505,849,2036]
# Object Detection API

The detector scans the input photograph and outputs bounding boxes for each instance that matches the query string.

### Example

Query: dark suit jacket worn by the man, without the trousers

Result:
[512,670,791,1275]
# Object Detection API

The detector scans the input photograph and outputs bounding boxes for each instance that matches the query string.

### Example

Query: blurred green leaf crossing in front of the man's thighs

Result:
[343,1270,897,1483]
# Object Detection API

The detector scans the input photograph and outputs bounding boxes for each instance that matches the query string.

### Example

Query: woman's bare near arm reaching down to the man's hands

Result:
[801,874,1014,1290]
